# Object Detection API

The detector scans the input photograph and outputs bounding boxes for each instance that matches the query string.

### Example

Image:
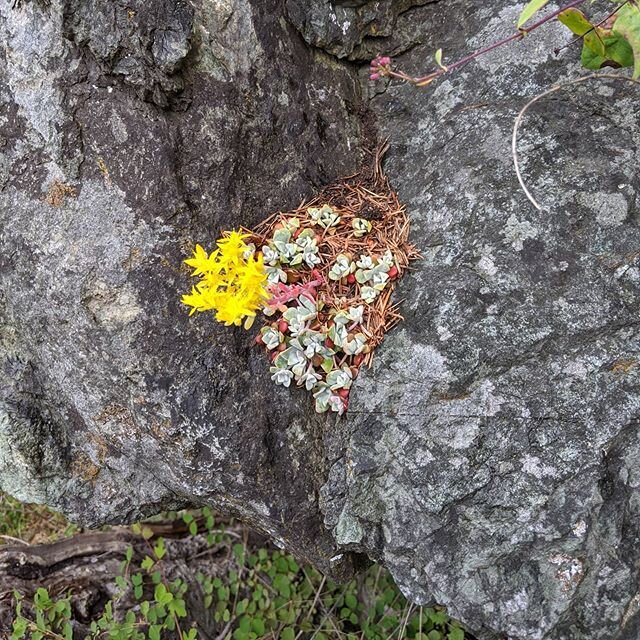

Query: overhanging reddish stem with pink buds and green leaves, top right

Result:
[369,0,640,87]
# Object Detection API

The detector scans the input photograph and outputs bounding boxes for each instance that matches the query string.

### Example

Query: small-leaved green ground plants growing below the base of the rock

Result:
[10,508,468,640]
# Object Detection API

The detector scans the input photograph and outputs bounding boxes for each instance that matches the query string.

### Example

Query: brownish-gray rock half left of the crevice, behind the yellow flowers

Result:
[0,0,363,572]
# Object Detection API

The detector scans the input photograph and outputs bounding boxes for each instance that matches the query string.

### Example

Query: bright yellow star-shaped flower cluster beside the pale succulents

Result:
[182,231,269,329]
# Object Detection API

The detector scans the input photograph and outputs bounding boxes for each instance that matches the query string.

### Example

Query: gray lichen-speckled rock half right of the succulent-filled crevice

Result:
[322,2,640,640]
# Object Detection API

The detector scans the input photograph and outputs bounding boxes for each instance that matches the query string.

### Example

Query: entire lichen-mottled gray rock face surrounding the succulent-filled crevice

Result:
[0,0,640,640]
